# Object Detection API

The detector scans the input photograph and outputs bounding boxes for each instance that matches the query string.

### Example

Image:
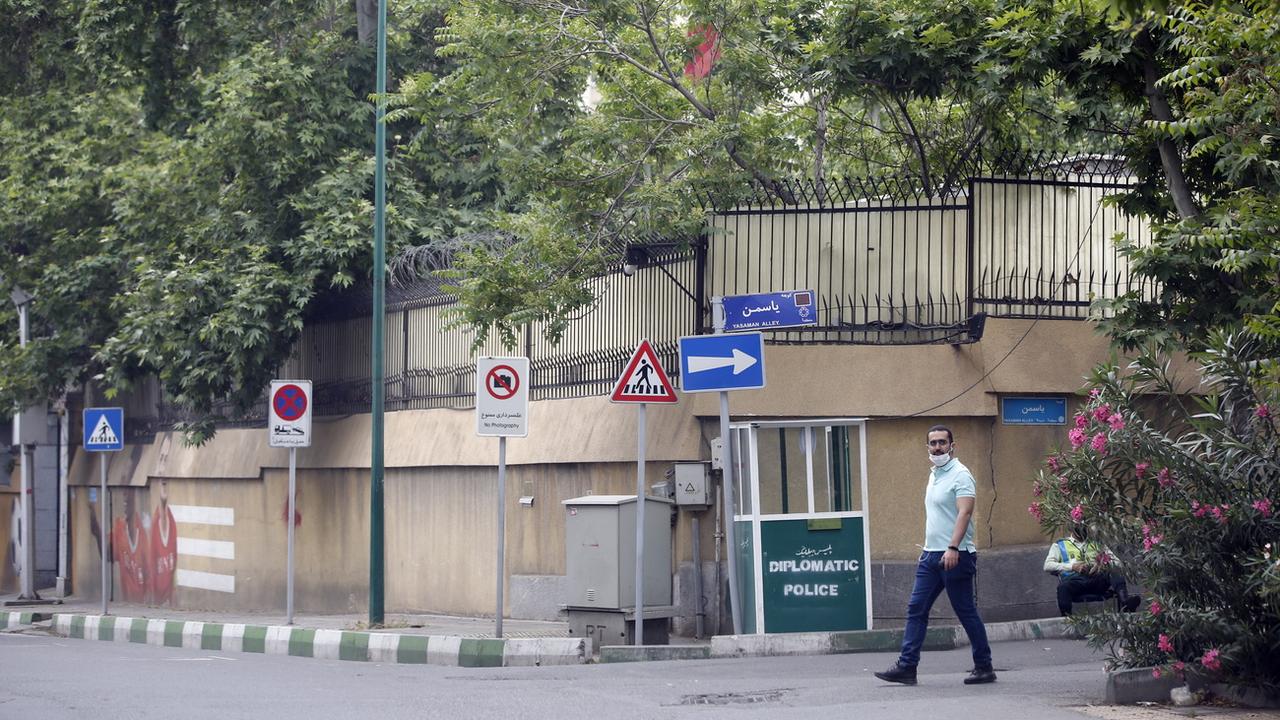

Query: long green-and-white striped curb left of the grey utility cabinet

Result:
[52,614,591,667]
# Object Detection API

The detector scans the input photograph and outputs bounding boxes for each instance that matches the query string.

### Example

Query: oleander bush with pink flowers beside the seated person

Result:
[1028,336,1280,692]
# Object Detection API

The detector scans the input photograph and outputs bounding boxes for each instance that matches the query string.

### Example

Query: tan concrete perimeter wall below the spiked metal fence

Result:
[62,320,1177,633]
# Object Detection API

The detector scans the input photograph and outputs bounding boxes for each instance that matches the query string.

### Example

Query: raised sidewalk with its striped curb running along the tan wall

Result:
[0,598,1074,667]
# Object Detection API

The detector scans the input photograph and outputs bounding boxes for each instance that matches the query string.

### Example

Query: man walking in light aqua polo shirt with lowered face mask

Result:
[876,425,996,685]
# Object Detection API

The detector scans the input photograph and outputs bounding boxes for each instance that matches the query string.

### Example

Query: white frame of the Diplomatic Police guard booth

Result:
[730,418,872,634]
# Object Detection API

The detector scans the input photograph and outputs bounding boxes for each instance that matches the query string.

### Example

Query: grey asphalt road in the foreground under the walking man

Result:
[0,633,1105,720]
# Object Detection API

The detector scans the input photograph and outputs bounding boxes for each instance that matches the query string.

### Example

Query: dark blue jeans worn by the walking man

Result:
[897,551,991,667]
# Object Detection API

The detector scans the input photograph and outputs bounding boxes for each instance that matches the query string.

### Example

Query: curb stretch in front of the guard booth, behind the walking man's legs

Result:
[706,618,1079,662]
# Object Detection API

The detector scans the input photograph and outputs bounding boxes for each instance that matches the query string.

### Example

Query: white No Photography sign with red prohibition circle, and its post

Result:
[476,357,529,638]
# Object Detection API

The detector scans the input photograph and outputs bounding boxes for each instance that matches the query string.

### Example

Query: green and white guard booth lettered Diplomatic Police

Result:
[730,419,872,633]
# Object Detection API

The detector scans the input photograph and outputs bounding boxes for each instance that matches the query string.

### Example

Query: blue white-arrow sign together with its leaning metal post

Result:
[680,326,764,635]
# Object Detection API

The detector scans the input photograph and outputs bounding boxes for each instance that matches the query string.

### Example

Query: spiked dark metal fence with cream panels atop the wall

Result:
[145,151,1157,415]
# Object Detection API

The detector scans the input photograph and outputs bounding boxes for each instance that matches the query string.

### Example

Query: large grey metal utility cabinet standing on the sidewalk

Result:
[563,495,675,646]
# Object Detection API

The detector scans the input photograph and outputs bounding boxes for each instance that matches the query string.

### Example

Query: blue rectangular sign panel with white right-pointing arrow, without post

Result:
[680,333,764,392]
